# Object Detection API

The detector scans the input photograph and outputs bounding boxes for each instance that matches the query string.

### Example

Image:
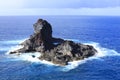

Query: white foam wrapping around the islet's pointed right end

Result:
[61,42,120,71]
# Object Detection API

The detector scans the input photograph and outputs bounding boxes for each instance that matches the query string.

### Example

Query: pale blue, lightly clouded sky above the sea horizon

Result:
[0,0,120,16]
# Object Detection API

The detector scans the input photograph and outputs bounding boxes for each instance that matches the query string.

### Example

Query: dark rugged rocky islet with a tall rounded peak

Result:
[10,19,97,65]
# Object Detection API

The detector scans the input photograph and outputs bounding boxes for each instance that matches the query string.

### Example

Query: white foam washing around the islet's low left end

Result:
[6,45,54,65]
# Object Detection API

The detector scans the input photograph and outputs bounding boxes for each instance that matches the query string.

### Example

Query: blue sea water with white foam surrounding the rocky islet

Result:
[0,16,120,80]
